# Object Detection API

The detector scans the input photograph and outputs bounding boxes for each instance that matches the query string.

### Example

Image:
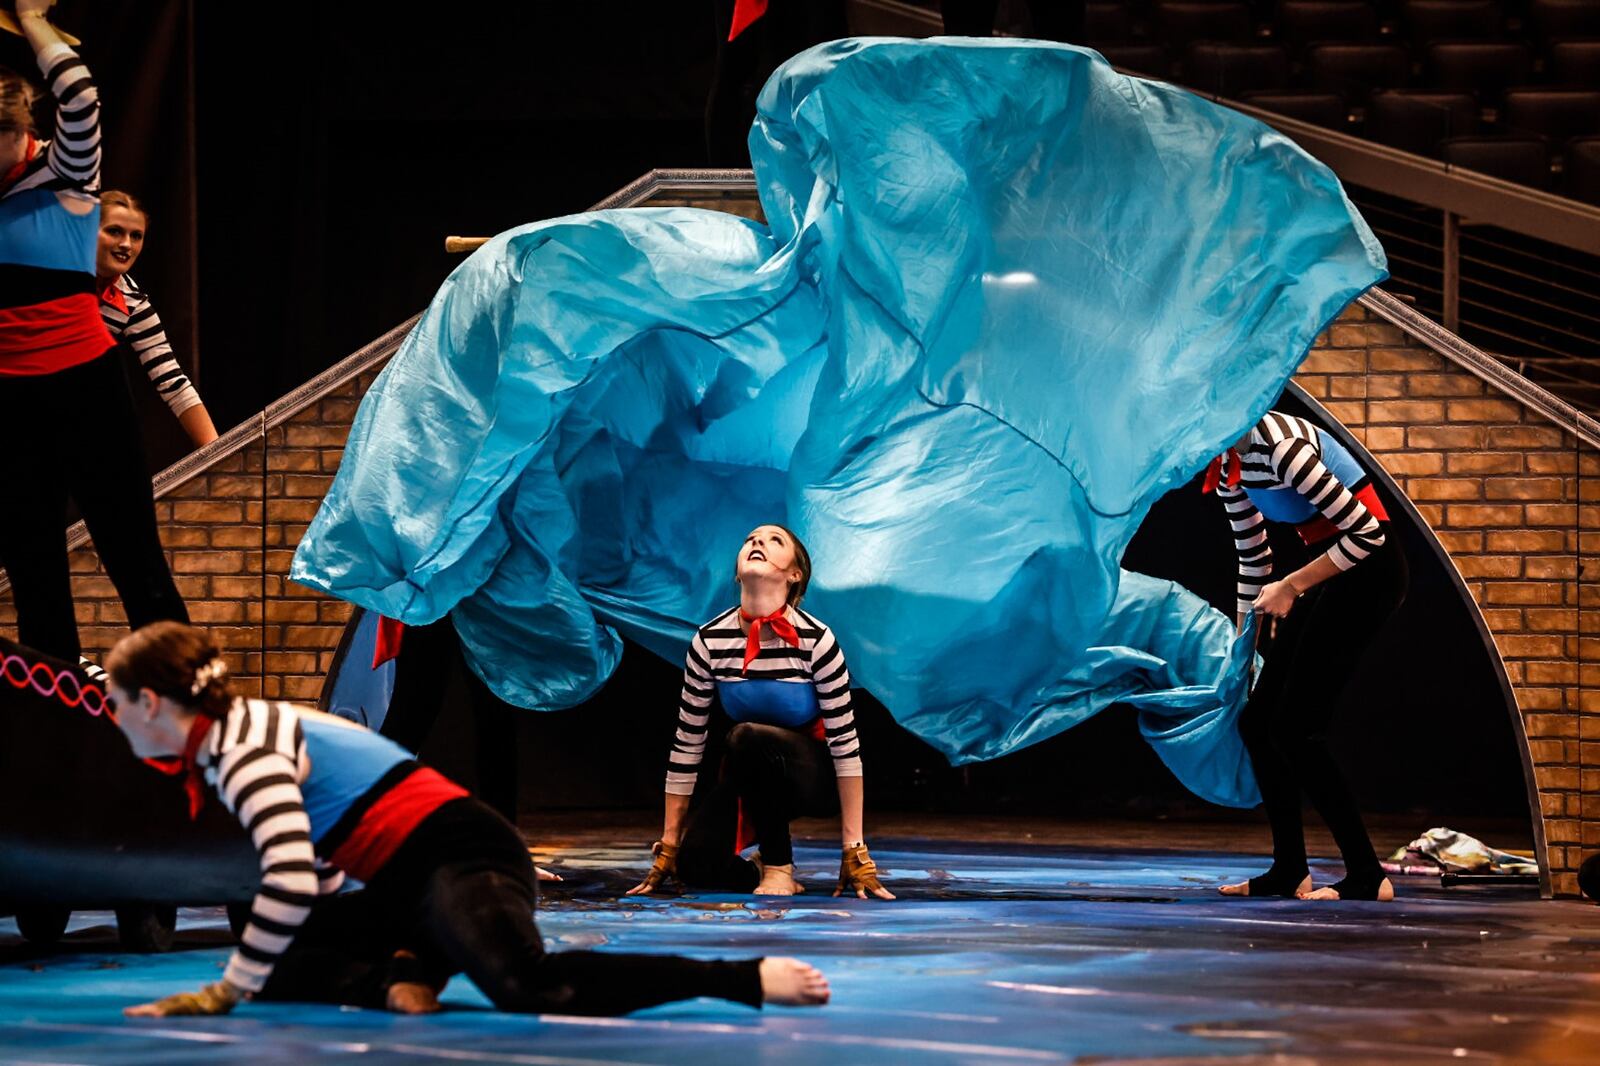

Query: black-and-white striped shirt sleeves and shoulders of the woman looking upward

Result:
[667,607,861,795]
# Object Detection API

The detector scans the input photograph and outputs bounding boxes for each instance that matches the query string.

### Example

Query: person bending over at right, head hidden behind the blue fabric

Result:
[1205,411,1408,900]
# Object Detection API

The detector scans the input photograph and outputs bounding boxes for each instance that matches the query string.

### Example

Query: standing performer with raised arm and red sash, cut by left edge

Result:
[0,0,189,659]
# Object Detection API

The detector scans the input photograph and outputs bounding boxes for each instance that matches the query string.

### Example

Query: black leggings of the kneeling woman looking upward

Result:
[678,722,838,892]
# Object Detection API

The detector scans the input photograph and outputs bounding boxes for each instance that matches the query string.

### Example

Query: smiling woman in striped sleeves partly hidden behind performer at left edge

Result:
[94,189,216,448]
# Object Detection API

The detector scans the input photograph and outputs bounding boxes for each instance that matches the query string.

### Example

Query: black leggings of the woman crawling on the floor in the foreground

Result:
[261,799,762,1015]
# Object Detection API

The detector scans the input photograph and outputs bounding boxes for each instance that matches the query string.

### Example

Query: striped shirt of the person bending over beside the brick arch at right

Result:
[1216,411,1384,615]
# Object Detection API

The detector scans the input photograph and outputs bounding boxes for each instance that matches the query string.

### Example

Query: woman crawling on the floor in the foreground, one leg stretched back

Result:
[106,623,829,1016]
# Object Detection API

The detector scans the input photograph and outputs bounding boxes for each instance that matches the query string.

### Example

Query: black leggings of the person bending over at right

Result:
[1238,531,1410,890]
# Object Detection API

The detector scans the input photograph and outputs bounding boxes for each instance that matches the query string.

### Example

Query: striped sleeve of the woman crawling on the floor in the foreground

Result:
[195,699,344,992]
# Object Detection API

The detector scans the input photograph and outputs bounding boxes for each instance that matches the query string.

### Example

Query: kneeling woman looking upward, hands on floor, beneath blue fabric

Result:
[629,525,894,900]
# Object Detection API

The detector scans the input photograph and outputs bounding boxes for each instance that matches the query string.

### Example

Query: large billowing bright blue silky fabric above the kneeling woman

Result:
[293,38,1386,805]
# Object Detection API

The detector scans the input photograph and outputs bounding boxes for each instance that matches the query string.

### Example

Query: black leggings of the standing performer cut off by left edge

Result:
[0,349,189,661]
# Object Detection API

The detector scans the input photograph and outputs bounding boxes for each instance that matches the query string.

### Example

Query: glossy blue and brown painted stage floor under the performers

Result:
[0,839,1600,1066]
